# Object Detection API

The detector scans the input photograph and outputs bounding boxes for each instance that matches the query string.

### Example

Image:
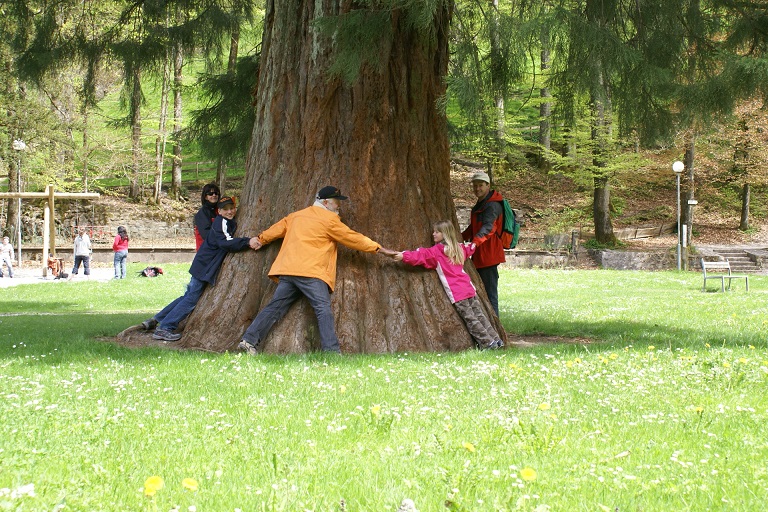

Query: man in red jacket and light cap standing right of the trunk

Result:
[461,172,506,316]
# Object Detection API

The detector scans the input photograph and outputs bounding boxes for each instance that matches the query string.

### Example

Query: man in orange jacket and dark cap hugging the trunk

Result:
[238,186,396,354]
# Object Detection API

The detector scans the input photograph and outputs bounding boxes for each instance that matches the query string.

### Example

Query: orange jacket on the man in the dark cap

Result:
[259,206,381,292]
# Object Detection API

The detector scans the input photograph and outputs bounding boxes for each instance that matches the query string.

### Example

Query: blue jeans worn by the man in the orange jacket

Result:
[243,276,340,352]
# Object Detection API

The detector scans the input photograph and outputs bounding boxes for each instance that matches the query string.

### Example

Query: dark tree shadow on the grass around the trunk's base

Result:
[0,304,766,365]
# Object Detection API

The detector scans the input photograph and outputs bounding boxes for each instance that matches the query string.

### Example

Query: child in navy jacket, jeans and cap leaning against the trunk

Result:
[141,197,258,341]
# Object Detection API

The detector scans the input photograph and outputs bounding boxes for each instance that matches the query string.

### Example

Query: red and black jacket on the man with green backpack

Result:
[461,190,506,268]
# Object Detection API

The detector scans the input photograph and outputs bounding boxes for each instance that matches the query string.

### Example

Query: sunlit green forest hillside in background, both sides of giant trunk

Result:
[0,0,768,244]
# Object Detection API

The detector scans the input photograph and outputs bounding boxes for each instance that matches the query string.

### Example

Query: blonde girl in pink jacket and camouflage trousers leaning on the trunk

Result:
[394,220,504,350]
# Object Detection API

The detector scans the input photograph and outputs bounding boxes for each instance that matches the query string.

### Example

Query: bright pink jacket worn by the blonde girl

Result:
[403,243,477,304]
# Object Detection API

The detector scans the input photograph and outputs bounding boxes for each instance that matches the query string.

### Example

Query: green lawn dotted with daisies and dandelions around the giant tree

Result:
[0,265,768,512]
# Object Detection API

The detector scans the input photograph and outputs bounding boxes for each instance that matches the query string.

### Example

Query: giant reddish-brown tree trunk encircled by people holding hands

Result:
[169,0,503,353]
